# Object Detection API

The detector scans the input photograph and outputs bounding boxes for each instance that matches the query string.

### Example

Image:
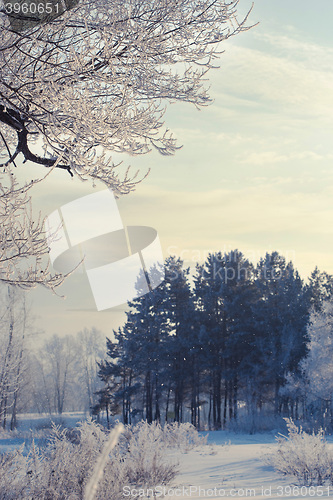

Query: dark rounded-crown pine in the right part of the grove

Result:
[254,252,308,414]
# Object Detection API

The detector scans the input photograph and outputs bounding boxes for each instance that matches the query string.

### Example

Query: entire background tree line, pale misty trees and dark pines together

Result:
[0,251,333,430]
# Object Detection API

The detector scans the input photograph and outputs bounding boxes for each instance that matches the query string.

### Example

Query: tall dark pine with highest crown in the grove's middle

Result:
[195,250,254,429]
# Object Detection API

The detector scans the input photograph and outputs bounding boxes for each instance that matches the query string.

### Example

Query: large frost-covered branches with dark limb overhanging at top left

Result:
[0,0,247,194]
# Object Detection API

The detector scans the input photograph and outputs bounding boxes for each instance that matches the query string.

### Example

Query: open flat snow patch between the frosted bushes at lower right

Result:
[163,431,333,500]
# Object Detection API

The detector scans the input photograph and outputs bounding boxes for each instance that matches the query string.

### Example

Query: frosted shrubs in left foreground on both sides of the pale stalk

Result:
[0,420,205,500]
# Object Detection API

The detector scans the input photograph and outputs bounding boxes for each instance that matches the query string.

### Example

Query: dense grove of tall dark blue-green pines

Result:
[94,250,333,429]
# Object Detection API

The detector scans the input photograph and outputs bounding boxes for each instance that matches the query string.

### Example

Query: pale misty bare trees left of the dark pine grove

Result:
[0,286,105,429]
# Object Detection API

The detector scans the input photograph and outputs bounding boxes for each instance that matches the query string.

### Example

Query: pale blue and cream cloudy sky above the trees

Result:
[26,0,333,334]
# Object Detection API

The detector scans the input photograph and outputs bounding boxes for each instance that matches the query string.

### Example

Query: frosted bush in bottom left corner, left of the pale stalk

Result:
[0,421,111,500]
